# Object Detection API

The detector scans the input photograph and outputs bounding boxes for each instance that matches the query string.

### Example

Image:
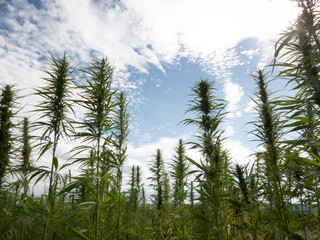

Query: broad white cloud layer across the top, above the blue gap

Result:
[0,0,295,115]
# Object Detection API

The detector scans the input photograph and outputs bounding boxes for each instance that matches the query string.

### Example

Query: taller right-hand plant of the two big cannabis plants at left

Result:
[76,58,114,240]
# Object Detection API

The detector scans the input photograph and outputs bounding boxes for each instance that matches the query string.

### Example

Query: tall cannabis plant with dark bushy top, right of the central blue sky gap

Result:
[183,79,228,239]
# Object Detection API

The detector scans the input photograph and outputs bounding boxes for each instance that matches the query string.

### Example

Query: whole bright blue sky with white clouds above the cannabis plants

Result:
[0,0,297,194]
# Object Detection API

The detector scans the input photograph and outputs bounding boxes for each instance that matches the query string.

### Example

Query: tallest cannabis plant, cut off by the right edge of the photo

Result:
[273,0,320,234]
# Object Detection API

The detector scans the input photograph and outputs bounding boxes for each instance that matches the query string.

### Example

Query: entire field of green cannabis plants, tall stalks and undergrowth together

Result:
[0,0,320,240]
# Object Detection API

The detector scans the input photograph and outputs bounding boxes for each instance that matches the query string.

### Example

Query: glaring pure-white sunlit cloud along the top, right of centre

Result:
[123,0,293,61]
